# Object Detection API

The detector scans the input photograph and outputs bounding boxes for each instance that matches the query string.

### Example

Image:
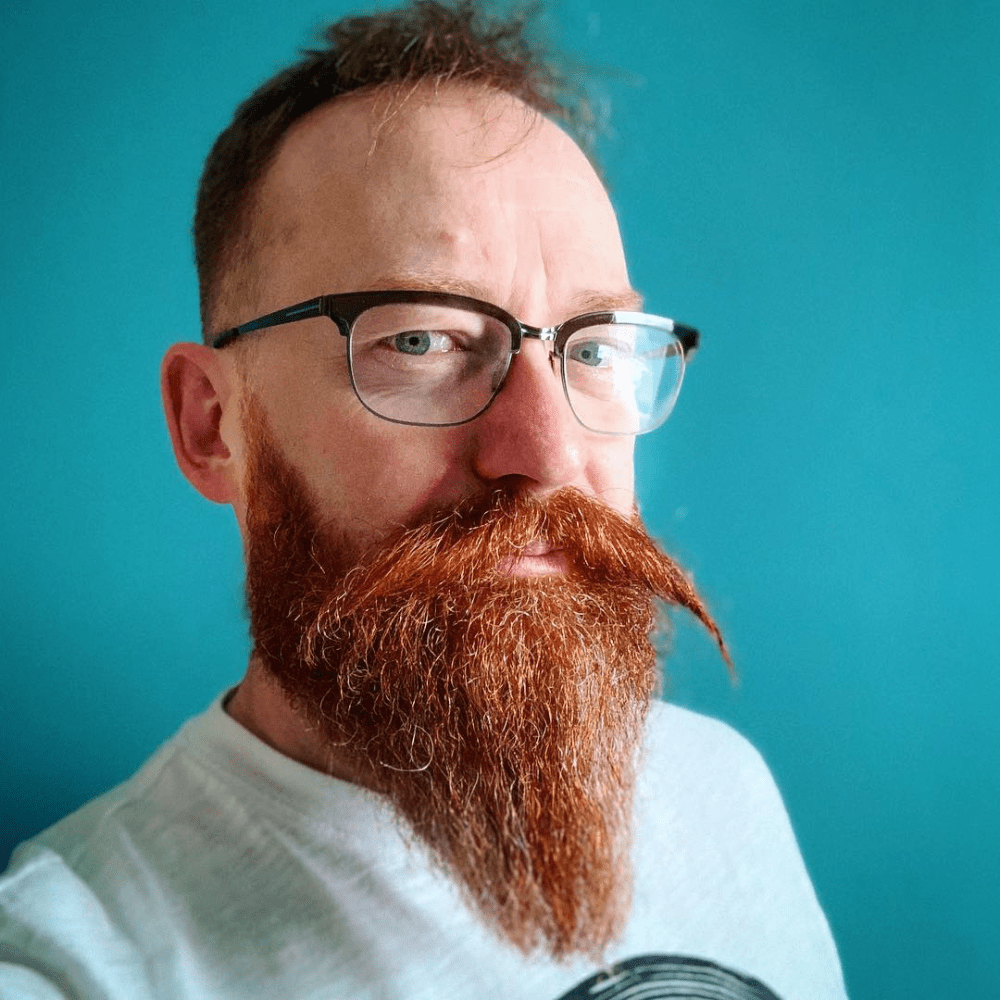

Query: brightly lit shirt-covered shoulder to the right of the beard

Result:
[635,704,844,1000]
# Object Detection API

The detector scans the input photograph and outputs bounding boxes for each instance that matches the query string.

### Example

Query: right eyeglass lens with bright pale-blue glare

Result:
[563,323,684,434]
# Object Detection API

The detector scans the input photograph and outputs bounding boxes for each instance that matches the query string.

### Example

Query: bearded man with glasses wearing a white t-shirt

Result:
[0,3,843,1000]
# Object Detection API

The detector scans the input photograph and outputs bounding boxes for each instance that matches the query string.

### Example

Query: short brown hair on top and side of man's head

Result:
[194,0,588,340]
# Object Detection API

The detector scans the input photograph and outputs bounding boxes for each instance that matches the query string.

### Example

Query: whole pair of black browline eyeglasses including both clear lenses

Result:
[212,290,699,435]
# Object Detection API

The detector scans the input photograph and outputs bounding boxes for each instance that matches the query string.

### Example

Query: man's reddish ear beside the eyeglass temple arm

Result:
[160,344,241,503]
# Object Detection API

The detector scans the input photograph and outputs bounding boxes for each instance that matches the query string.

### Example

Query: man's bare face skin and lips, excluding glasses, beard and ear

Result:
[233,88,636,556]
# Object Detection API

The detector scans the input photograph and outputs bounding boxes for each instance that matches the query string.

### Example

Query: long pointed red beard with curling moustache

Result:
[247,405,725,958]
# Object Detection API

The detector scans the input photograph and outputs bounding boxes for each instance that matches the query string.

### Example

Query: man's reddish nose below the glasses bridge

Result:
[473,341,588,493]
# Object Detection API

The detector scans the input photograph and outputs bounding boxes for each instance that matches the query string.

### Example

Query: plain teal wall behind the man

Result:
[0,0,1000,1000]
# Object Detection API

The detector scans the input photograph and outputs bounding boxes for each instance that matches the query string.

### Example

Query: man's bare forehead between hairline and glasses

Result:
[248,86,627,307]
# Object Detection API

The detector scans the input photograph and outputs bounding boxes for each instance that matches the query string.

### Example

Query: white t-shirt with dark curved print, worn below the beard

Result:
[0,699,845,1000]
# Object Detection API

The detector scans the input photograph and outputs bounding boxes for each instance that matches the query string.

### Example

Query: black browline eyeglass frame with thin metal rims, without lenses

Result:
[209,288,701,434]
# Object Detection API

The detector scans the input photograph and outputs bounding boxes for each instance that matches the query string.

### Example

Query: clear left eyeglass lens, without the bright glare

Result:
[350,303,511,425]
